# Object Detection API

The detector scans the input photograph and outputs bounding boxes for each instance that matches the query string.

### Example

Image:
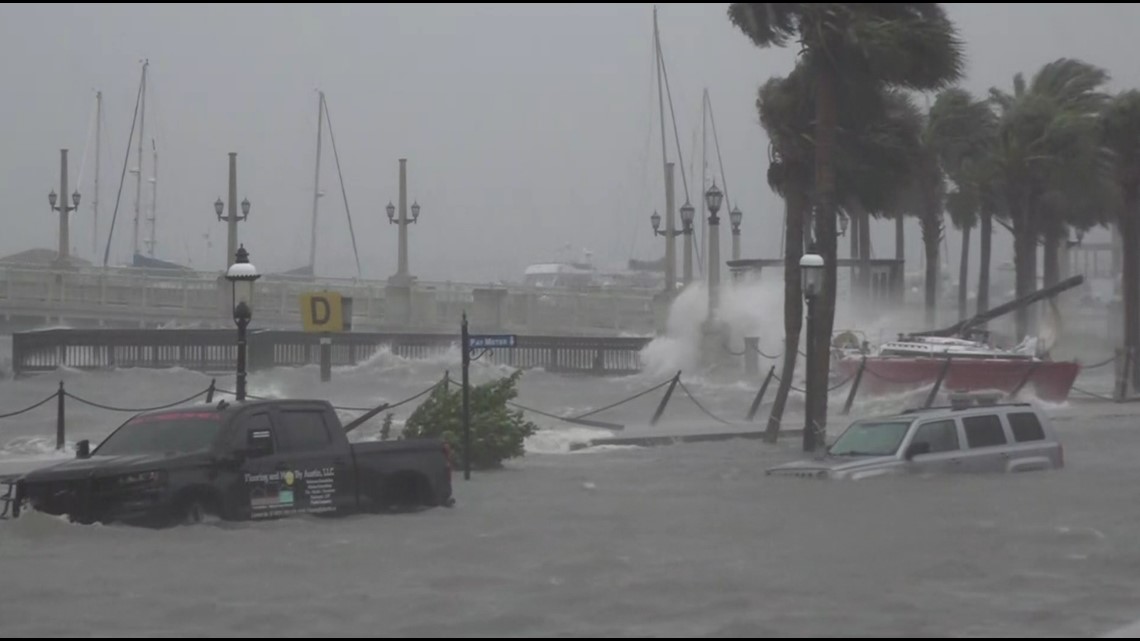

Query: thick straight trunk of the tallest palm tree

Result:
[805,64,839,451]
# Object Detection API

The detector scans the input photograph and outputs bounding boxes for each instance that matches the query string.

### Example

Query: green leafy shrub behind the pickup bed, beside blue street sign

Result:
[401,370,538,470]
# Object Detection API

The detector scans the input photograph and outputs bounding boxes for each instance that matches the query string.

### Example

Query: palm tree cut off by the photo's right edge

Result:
[1100,89,1140,389]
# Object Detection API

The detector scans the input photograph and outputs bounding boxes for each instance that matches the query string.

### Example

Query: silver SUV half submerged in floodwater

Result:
[766,403,1065,480]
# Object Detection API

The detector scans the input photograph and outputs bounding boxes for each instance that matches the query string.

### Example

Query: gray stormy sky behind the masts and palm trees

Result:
[0,3,1140,282]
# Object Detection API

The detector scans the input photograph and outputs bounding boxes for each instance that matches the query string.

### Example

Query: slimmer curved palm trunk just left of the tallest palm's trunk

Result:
[764,188,807,443]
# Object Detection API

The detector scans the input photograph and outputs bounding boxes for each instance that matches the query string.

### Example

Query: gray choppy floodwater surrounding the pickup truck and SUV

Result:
[0,335,1140,638]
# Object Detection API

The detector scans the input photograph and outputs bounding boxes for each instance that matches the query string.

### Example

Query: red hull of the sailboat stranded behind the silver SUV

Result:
[836,356,1081,403]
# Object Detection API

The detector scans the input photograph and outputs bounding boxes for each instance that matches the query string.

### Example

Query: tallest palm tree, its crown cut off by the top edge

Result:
[728,2,963,449]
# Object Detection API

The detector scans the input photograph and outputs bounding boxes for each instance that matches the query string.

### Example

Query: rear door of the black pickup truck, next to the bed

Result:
[274,406,356,513]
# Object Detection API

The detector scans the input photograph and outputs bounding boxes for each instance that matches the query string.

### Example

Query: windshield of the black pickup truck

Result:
[92,412,221,456]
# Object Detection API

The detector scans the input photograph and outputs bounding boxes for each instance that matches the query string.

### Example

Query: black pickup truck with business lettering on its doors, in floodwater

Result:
[11,399,455,527]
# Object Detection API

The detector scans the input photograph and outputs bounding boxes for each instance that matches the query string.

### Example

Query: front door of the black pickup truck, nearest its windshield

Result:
[229,409,295,519]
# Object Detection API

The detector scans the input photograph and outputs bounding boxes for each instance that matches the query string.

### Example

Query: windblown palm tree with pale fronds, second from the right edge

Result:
[990,58,1108,338]
